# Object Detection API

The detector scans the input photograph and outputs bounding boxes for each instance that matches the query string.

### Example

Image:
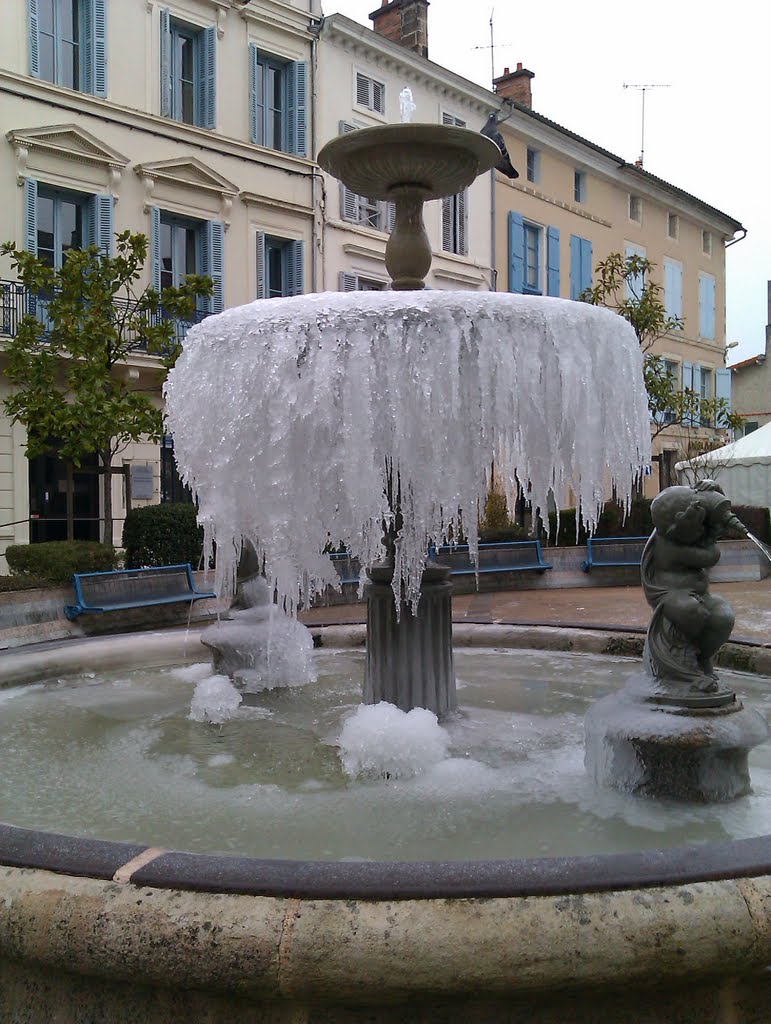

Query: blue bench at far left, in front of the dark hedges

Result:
[65,562,217,622]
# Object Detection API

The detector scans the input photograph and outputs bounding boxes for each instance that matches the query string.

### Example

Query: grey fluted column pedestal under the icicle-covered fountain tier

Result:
[363,563,458,718]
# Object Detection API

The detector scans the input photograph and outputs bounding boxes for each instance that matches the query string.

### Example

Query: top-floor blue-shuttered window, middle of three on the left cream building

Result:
[161,8,217,128]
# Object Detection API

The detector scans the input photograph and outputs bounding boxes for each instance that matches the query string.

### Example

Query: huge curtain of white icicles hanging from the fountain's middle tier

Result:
[165,291,650,607]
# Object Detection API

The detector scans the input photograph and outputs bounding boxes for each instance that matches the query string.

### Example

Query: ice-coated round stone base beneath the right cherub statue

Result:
[584,672,769,803]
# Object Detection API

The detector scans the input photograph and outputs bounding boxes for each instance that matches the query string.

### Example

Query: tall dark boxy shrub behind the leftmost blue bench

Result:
[123,502,204,569]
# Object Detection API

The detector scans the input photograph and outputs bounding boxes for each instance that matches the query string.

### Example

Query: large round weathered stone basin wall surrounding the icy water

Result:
[0,628,771,1024]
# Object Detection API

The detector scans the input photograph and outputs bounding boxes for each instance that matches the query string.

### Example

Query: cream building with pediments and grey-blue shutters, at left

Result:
[0,0,319,554]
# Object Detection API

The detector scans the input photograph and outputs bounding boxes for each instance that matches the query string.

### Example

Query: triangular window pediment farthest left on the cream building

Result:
[5,125,129,195]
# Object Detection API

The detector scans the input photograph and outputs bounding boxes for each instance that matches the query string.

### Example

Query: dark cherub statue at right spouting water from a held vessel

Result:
[642,480,746,693]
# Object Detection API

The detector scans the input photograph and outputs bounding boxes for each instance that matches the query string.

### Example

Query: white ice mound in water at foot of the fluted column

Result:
[338,700,449,778]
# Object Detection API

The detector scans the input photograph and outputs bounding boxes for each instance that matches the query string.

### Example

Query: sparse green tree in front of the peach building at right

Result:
[581,253,742,444]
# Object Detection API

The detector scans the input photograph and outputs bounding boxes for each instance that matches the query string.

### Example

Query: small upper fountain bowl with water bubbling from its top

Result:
[318,124,501,200]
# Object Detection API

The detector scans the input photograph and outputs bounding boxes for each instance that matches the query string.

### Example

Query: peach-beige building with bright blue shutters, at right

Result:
[495,65,743,496]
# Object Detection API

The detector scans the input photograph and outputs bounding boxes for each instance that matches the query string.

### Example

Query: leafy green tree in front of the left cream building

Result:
[0,231,213,544]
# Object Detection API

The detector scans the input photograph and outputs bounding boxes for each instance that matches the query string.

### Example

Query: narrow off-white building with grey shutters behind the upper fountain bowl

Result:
[316,12,496,292]
